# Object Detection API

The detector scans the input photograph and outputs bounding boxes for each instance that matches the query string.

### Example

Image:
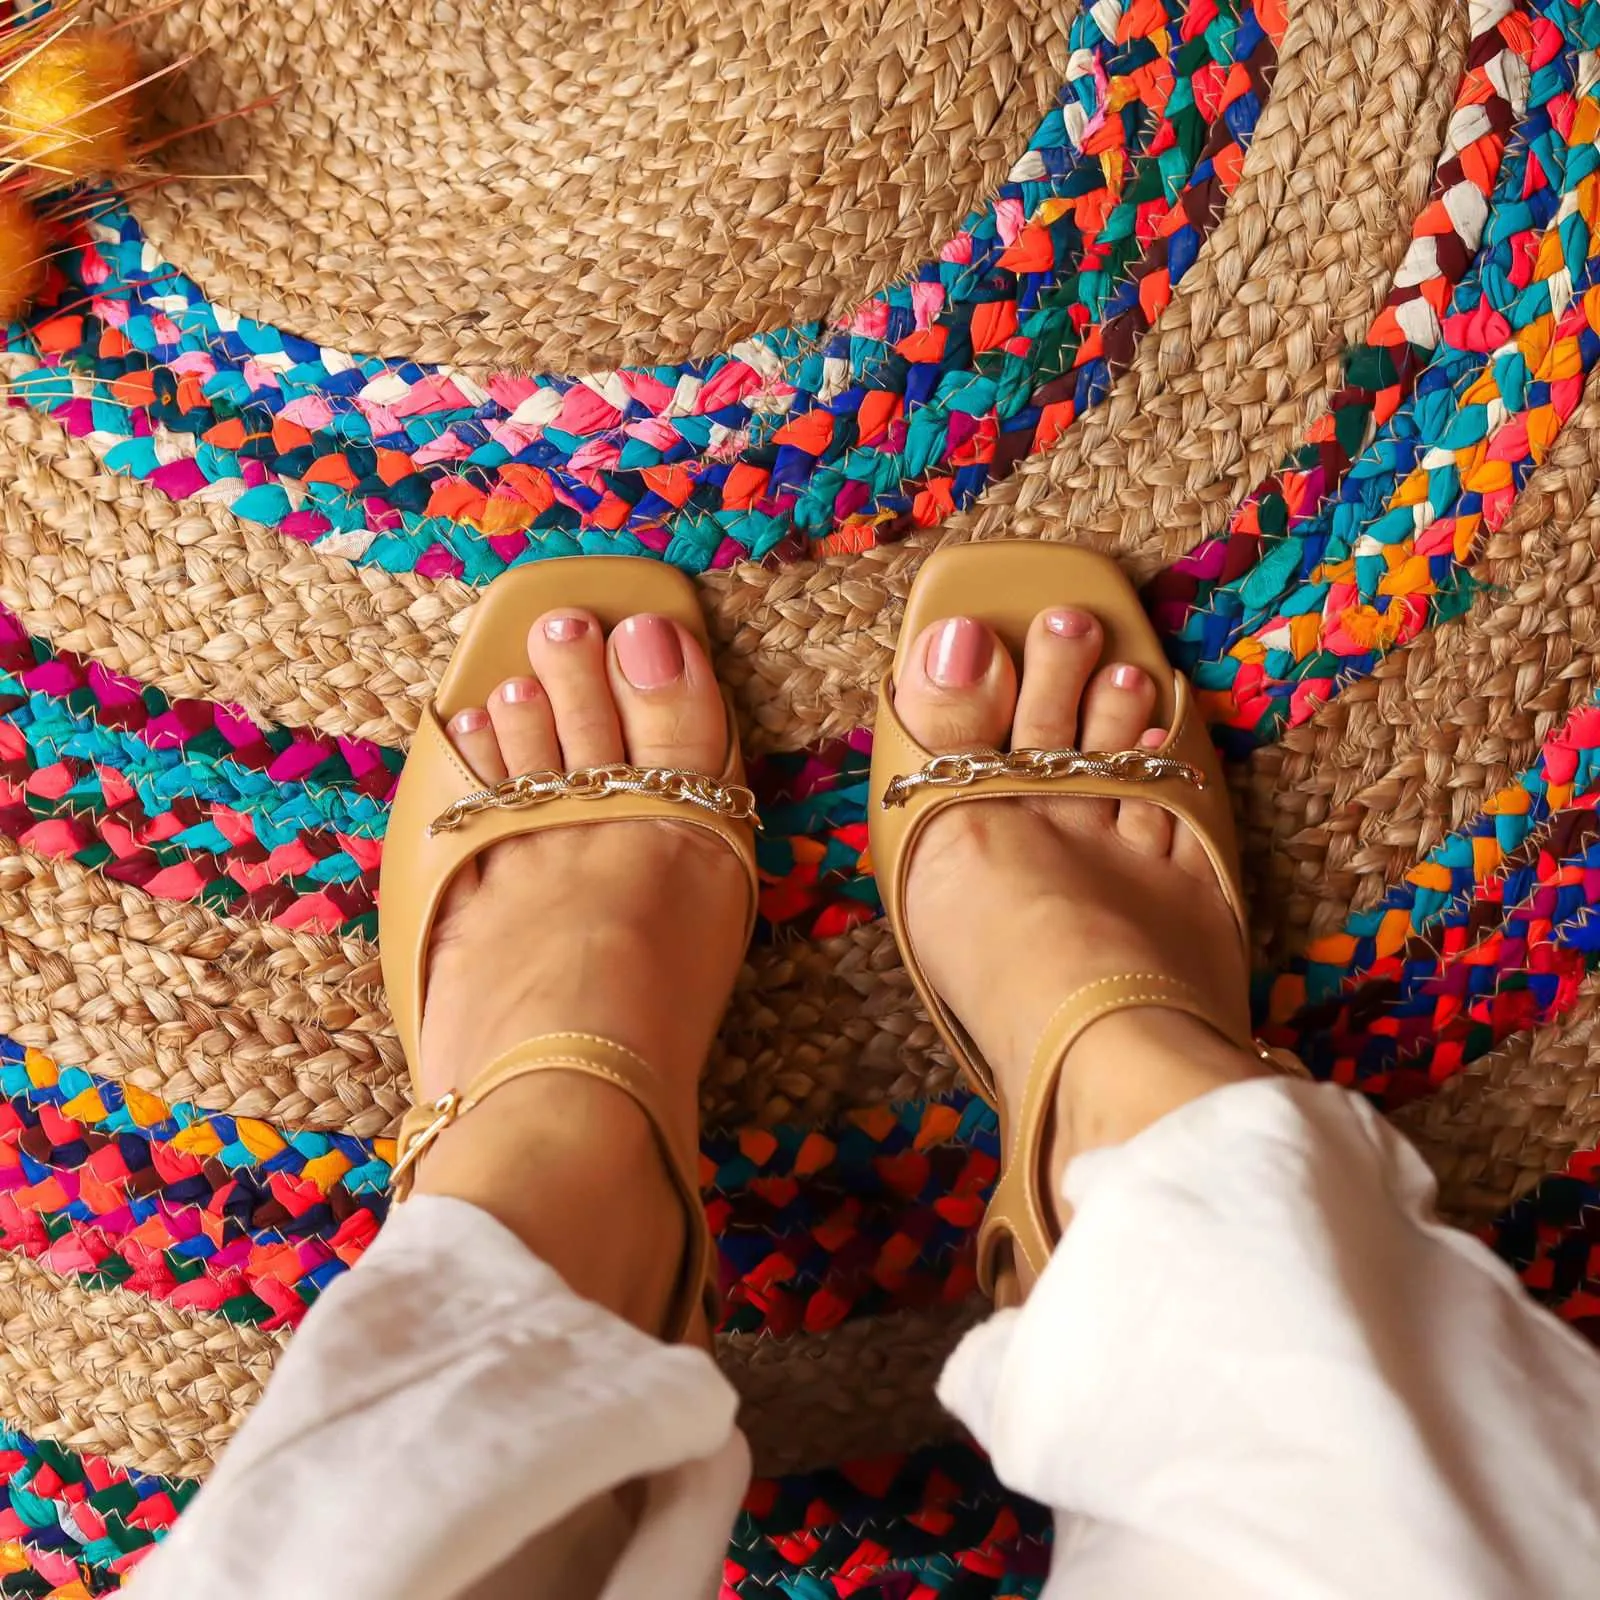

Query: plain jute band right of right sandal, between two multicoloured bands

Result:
[1232,373,1600,960]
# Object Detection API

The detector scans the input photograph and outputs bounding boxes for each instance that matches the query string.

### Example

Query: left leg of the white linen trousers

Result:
[130,1195,750,1600]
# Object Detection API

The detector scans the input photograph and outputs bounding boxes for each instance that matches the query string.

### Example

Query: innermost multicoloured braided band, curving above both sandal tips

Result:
[8,0,1283,582]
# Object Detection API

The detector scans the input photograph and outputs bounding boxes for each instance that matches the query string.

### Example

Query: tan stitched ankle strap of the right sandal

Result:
[978,973,1292,1299]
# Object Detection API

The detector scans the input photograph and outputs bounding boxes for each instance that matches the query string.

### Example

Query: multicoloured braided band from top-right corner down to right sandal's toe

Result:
[1163,0,1600,749]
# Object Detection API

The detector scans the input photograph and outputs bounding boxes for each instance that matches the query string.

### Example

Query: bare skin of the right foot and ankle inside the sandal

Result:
[894,608,1262,1221]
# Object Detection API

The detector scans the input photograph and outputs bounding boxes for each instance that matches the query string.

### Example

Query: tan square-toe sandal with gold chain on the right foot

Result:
[869,541,1304,1304]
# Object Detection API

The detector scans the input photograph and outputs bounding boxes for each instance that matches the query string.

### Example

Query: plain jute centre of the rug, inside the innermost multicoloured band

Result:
[99,0,1069,371]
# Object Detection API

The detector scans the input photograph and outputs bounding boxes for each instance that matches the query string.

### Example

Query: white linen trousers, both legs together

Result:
[133,1080,1600,1600]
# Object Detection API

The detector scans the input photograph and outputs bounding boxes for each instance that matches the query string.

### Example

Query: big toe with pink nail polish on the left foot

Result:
[610,614,728,776]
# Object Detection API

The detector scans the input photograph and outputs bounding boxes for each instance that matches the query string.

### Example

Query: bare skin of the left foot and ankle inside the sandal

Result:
[406,610,749,1331]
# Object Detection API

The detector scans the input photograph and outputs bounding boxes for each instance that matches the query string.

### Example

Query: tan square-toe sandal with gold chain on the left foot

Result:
[378,557,757,1339]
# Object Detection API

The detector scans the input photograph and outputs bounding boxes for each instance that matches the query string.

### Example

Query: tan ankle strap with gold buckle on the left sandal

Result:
[389,1034,720,1342]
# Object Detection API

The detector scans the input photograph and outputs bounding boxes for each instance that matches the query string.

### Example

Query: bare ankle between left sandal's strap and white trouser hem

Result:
[416,1072,686,1333]
